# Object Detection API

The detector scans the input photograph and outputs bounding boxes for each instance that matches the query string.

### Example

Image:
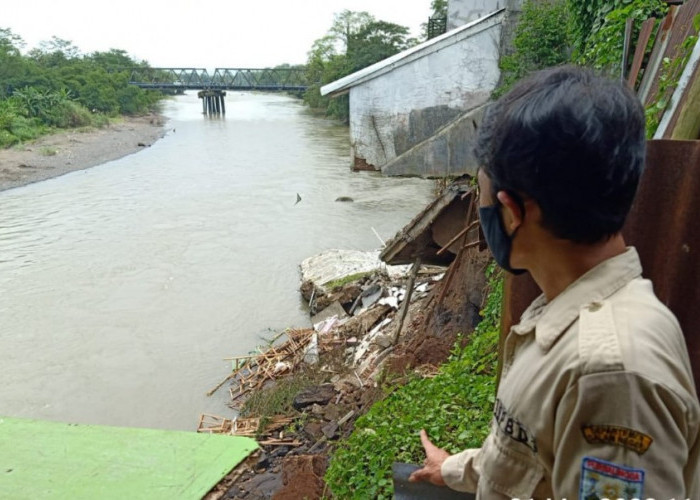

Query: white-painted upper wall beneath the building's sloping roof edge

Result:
[350,17,501,169]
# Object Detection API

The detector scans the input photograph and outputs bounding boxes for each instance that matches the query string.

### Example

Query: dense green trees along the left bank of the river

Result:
[0,28,163,147]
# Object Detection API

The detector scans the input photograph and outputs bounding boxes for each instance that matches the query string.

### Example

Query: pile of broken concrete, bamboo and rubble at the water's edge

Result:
[198,252,445,499]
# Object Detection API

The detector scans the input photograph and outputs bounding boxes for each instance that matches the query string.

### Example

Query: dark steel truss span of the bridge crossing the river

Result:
[122,68,309,92]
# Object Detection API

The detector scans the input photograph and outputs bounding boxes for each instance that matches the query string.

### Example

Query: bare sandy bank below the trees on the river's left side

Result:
[0,114,165,191]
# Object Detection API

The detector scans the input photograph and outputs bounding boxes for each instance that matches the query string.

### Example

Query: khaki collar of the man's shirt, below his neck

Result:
[512,247,642,351]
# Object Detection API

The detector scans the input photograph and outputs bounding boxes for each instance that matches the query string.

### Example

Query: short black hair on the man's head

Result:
[474,66,646,243]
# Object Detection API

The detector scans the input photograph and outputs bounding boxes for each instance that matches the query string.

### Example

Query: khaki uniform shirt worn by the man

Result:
[442,248,700,500]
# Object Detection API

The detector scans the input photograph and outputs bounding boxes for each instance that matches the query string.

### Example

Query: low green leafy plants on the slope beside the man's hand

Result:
[325,265,503,499]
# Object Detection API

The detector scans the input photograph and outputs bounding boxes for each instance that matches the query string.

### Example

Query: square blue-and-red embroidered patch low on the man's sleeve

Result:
[579,457,644,500]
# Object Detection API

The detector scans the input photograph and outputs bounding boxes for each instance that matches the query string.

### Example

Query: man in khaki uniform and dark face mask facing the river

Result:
[411,67,700,500]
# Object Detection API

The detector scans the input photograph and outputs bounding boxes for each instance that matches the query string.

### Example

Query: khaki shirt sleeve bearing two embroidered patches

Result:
[552,371,700,498]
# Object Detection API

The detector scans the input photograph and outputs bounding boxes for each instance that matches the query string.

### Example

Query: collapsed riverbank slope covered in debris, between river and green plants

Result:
[198,250,482,500]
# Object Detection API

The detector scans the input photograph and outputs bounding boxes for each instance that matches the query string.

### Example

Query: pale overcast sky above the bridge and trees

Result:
[0,0,430,69]
